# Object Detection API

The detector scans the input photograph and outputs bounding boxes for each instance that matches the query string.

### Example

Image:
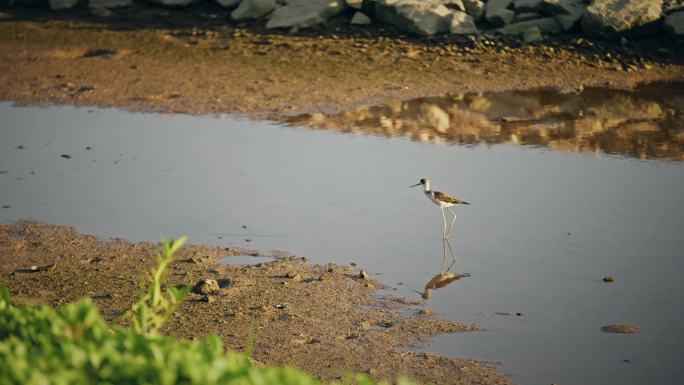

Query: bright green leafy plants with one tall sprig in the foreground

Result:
[0,237,410,385]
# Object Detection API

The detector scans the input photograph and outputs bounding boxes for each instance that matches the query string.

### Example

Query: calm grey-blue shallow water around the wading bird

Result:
[0,84,684,384]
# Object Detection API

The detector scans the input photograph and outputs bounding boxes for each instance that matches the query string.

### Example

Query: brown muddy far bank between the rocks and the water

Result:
[0,5,684,118]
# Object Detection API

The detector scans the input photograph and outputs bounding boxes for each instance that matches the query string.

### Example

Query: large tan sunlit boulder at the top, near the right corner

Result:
[582,0,663,38]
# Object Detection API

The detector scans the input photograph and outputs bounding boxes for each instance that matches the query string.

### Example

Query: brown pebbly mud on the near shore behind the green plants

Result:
[0,221,508,384]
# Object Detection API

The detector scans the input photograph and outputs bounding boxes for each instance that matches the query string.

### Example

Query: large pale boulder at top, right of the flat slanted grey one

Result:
[375,0,452,36]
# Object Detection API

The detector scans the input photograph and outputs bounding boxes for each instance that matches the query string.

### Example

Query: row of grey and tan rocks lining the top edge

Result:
[10,0,684,43]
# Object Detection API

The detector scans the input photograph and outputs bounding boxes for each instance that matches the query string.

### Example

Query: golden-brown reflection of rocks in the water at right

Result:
[288,83,684,160]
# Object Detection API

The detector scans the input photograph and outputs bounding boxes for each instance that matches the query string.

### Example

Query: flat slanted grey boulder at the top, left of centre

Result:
[266,0,347,28]
